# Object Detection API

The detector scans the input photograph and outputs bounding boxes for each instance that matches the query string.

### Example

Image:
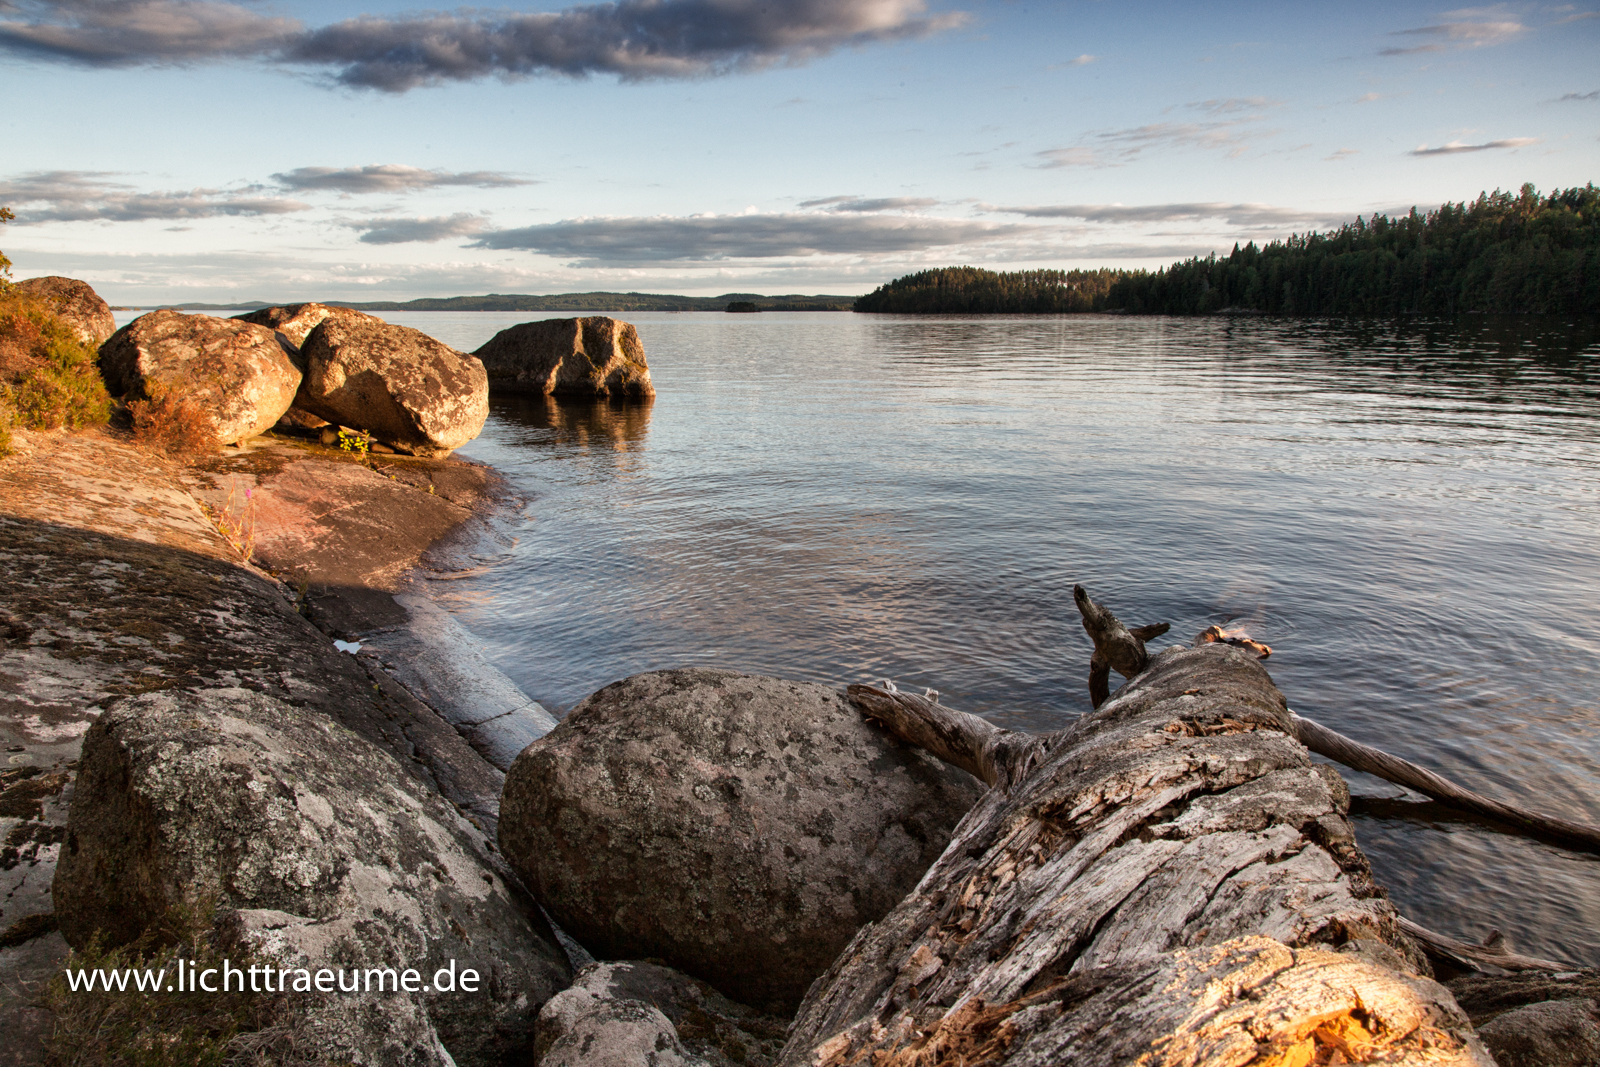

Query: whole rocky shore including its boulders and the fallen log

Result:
[0,280,1600,1067]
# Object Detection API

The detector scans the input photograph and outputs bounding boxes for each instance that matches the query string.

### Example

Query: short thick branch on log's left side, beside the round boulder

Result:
[846,685,1046,790]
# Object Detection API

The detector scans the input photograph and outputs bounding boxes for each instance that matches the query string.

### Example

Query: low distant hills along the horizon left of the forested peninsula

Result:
[144,293,856,312]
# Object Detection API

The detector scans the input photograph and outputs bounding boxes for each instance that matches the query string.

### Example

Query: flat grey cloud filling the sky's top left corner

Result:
[0,0,301,67]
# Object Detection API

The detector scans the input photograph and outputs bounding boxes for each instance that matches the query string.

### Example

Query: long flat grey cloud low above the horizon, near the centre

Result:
[472,213,1034,266]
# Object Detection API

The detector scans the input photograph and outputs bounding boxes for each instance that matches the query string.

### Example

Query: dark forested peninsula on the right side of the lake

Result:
[854,182,1600,315]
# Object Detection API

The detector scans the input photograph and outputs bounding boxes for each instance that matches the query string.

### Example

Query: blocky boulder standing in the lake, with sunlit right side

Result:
[474,315,656,398]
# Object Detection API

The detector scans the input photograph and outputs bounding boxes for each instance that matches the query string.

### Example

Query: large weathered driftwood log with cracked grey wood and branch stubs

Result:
[781,593,1491,1067]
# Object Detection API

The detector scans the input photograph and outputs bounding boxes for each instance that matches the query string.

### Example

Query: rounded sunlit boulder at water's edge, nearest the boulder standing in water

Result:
[294,315,490,456]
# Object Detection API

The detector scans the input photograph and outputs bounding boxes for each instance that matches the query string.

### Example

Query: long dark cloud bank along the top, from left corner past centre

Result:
[0,0,968,93]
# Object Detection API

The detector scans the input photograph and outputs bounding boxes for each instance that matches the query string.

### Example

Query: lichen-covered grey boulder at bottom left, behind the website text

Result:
[53,689,570,1067]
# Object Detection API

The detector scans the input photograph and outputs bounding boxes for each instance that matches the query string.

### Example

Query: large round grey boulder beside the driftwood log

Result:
[499,669,979,1011]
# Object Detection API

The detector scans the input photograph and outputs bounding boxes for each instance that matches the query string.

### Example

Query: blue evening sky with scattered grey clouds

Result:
[0,0,1600,306]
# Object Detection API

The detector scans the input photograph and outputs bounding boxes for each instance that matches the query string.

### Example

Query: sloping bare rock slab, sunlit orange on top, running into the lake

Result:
[0,429,555,1062]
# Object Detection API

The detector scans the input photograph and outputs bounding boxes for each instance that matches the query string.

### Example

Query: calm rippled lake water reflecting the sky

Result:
[124,314,1600,966]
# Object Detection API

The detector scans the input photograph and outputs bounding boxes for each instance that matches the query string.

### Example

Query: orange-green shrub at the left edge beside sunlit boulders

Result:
[0,290,110,448]
